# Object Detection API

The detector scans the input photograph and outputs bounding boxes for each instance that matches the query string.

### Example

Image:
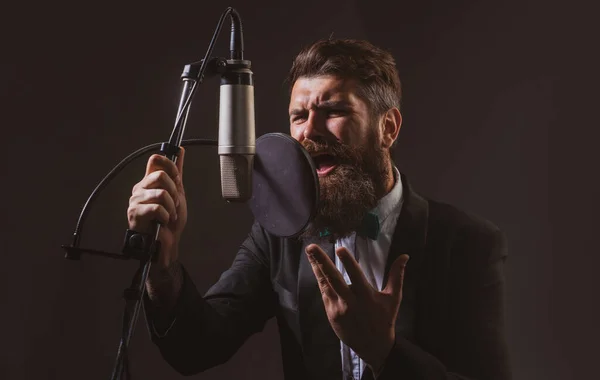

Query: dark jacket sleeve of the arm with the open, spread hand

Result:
[377,221,511,380]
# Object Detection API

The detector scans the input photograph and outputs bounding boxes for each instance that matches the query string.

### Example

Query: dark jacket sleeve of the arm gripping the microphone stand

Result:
[144,223,276,375]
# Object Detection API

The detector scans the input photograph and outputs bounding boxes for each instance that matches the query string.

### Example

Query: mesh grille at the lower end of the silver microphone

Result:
[219,154,254,202]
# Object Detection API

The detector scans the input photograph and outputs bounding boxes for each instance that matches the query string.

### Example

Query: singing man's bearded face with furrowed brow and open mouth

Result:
[289,76,391,238]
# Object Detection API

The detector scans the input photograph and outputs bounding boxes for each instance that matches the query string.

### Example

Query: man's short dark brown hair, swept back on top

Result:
[287,39,402,116]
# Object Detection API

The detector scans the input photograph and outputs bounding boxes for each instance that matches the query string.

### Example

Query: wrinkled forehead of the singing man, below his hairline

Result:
[290,75,363,109]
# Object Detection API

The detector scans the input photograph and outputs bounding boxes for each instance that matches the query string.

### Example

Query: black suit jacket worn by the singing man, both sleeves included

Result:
[145,176,510,380]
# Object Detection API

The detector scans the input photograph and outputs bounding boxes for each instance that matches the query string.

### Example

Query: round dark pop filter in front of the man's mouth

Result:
[250,133,319,237]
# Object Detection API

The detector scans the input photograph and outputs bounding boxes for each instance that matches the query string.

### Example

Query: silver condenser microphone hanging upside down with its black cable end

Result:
[218,11,256,202]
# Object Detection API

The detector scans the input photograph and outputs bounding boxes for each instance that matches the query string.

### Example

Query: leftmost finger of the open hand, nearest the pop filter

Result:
[306,244,351,299]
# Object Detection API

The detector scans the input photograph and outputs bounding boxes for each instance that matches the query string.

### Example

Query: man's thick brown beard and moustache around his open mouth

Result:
[301,134,391,241]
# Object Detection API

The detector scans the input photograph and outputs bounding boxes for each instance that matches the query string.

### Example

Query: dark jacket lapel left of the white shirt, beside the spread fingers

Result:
[298,238,342,379]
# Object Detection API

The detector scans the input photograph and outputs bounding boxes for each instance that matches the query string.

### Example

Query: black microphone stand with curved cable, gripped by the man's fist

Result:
[62,7,243,380]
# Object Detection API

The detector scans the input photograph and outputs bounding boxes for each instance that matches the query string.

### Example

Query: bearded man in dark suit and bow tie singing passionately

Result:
[128,40,510,380]
